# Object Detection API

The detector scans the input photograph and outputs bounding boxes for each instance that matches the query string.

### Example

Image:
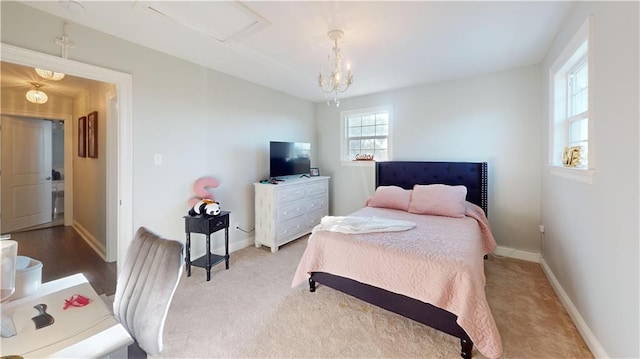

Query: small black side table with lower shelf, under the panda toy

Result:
[184,211,231,281]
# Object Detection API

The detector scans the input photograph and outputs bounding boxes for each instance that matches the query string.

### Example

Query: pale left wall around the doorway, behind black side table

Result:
[1,2,315,255]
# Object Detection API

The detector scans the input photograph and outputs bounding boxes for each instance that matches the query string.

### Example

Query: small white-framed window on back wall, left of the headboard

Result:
[340,106,391,162]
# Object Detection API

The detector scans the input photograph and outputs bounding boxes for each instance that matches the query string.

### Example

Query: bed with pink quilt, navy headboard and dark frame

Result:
[292,161,502,358]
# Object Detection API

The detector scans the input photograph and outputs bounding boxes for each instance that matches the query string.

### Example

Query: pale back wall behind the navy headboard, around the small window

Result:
[317,66,542,253]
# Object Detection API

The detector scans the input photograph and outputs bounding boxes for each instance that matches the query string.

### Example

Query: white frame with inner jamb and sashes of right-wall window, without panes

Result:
[547,17,595,183]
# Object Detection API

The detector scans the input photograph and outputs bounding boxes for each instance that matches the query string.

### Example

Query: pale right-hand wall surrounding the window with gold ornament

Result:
[541,2,640,358]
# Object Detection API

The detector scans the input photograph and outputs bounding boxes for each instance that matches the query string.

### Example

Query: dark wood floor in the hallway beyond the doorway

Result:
[11,226,117,295]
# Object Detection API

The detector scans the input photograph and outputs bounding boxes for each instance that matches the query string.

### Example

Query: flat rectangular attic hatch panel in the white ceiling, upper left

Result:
[134,1,271,43]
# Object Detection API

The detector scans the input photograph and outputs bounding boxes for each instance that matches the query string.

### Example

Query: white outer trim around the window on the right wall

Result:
[546,16,596,184]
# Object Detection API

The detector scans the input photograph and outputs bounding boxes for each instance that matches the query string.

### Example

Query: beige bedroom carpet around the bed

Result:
[162,237,592,358]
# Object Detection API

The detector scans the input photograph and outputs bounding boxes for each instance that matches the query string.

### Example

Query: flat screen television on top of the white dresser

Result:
[269,141,311,178]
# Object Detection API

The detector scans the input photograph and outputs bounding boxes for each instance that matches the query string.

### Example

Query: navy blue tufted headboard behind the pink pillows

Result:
[376,161,488,215]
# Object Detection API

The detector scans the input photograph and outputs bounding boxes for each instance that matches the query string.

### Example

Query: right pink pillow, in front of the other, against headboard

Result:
[408,184,467,218]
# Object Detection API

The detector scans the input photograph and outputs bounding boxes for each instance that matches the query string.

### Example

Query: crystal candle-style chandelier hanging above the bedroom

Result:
[318,29,353,107]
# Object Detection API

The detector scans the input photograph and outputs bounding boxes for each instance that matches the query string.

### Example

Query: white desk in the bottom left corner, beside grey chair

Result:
[0,274,133,359]
